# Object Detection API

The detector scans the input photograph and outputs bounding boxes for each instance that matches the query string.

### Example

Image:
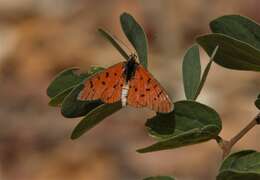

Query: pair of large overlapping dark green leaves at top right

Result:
[197,15,260,71]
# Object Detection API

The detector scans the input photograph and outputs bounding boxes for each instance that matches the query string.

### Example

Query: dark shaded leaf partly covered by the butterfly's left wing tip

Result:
[61,84,103,118]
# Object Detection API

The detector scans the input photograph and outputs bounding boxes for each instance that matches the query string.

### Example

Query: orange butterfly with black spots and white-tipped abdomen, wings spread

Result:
[78,54,173,113]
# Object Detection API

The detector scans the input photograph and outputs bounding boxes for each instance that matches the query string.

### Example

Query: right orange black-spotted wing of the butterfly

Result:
[127,65,173,113]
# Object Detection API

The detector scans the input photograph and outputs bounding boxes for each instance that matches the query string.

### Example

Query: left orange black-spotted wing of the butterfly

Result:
[78,63,125,103]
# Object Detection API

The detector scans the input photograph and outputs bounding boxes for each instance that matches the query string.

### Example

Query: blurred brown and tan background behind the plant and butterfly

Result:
[0,0,260,180]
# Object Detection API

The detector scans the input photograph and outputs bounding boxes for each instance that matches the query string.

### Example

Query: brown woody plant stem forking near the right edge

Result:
[216,113,260,159]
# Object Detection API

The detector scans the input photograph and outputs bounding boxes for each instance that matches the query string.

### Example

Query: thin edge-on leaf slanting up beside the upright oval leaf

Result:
[194,46,218,100]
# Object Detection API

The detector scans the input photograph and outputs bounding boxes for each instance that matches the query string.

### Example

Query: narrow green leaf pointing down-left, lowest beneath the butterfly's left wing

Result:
[71,102,122,139]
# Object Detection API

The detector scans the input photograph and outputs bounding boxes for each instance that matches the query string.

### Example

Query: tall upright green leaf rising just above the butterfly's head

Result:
[120,13,148,68]
